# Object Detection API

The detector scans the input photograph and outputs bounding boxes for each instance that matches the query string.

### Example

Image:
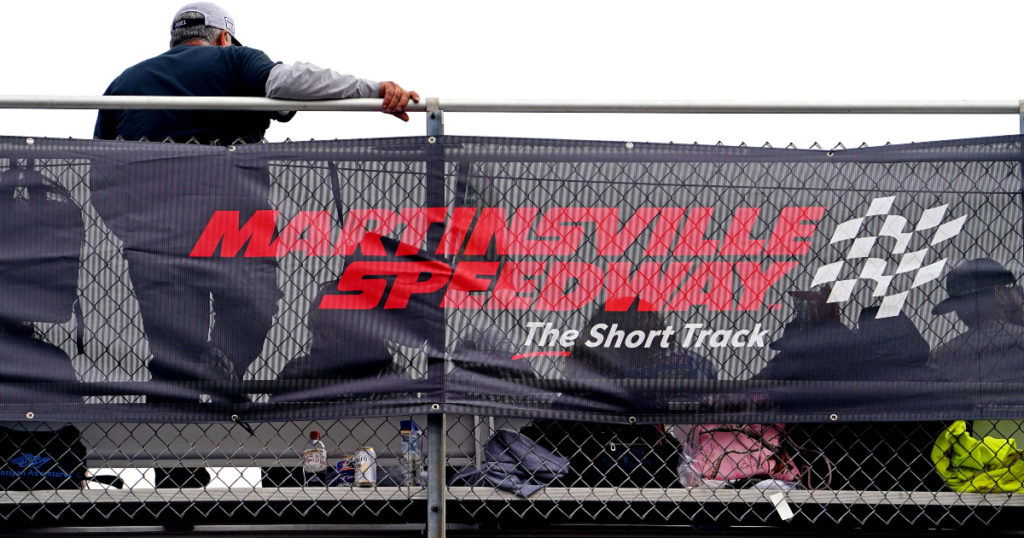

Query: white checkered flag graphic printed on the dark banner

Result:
[811,196,967,319]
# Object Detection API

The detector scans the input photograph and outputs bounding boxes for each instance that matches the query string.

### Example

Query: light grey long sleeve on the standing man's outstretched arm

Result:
[266,61,380,99]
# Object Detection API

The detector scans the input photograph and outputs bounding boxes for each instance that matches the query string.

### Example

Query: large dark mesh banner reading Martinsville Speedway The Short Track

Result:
[0,136,1024,422]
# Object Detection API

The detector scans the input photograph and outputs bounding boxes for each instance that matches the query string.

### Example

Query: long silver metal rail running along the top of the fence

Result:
[0,95,1024,115]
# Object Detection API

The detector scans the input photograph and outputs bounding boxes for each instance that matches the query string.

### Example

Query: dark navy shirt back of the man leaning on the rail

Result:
[94,45,285,144]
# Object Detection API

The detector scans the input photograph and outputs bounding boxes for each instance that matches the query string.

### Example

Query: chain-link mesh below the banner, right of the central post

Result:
[447,415,1024,529]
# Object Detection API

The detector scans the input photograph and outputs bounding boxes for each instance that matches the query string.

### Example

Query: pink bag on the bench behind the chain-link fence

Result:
[690,424,800,482]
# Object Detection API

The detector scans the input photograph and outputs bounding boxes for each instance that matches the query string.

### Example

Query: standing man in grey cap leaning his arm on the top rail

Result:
[92,2,420,403]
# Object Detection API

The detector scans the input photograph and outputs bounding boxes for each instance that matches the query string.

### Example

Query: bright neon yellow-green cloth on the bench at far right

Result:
[932,420,1024,493]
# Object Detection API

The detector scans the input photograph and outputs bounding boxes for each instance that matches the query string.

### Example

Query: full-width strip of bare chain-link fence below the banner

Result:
[0,416,1021,529]
